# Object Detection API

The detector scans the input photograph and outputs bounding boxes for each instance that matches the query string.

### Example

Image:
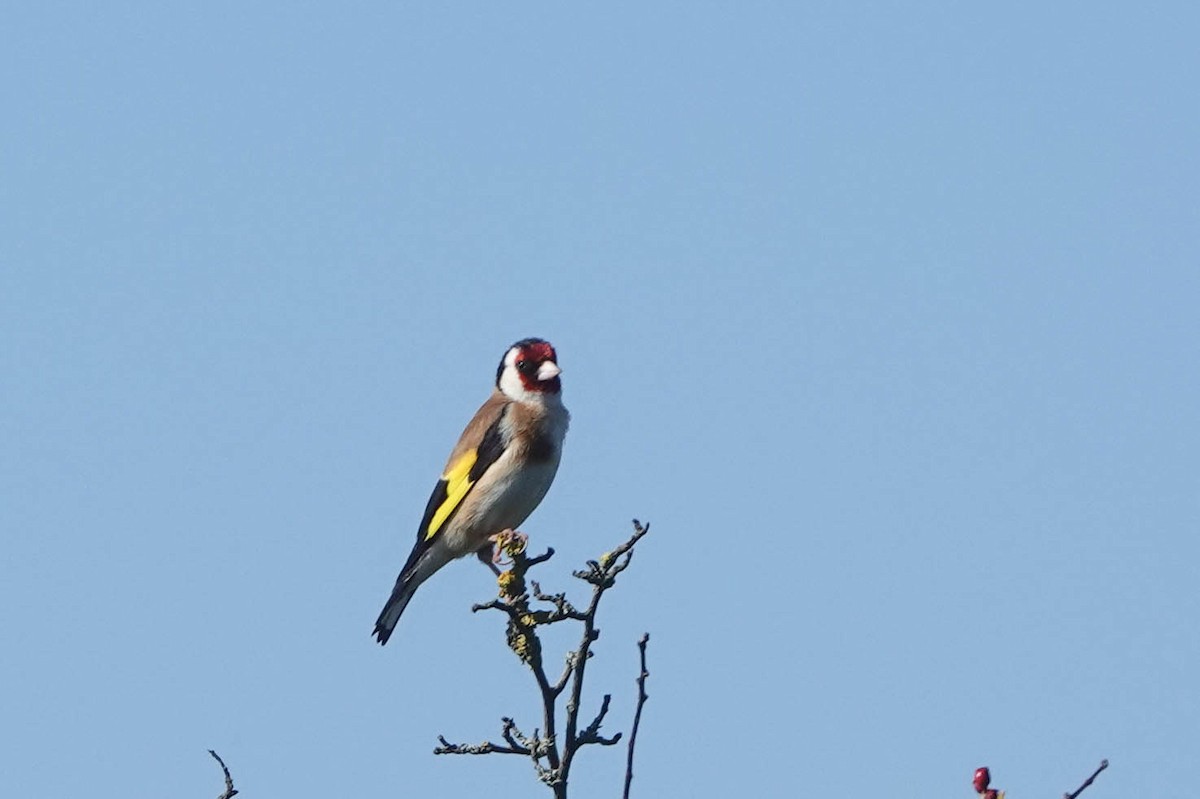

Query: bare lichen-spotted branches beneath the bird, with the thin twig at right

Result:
[433,519,649,799]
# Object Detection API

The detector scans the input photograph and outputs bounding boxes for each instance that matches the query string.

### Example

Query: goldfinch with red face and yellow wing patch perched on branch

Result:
[374,338,570,644]
